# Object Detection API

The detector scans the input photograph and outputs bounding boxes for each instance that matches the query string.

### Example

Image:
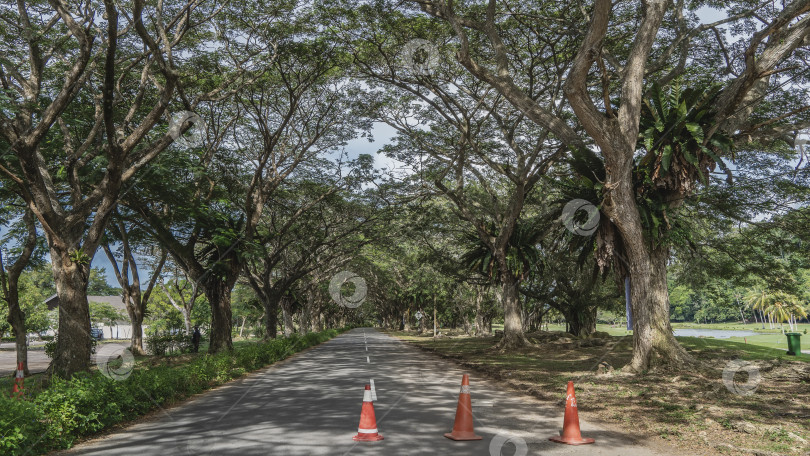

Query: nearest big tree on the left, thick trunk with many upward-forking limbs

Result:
[0,0,231,377]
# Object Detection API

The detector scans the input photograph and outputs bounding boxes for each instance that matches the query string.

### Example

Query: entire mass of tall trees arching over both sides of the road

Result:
[0,0,810,376]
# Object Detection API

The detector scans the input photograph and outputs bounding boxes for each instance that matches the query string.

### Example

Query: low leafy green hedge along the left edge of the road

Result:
[0,330,342,456]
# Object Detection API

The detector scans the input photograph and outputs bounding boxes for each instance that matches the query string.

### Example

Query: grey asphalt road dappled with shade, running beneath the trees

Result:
[52,328,675,456]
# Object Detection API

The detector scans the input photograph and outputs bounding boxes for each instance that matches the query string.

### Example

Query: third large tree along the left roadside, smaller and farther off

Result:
[245,175,378,338]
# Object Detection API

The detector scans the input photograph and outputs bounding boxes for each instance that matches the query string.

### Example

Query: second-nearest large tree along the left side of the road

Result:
[127,20,366,352]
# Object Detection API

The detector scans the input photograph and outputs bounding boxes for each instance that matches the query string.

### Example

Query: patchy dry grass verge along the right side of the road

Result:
[389,330,810,456]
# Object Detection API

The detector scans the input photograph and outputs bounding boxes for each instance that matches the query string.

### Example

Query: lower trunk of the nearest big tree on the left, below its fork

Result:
[51,248,91,378]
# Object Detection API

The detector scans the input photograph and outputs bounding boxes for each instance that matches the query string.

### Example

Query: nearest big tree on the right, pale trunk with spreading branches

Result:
[414,0,810,371]
